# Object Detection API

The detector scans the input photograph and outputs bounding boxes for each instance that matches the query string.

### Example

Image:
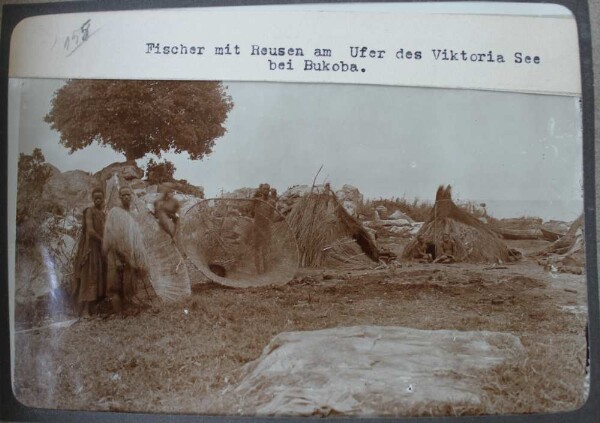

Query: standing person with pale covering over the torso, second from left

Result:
[102,187,155,313]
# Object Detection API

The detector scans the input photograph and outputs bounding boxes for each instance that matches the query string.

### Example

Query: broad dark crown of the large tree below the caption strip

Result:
[44,80,233,160]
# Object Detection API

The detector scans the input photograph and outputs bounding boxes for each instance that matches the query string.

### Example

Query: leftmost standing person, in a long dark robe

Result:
[71,188,106,317]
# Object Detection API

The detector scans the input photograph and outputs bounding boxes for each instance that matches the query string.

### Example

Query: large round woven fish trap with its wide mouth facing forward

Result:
[180,198,298,287]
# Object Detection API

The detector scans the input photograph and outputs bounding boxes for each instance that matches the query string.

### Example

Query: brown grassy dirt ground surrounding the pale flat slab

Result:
[14,241,587,415]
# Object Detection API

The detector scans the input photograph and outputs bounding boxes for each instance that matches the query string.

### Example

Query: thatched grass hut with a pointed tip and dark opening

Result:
[402,185,511,263]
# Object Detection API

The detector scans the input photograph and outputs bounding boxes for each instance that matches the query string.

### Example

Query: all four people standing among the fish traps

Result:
[71,184,277,317]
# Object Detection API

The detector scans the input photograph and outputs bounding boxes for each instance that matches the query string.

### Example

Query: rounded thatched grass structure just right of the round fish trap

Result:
[287,192,379,267]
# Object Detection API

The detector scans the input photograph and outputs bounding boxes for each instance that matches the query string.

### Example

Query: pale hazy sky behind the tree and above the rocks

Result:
[10,79,583,220]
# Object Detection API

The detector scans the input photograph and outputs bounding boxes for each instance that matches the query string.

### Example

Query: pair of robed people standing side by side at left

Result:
[71,187,152,317]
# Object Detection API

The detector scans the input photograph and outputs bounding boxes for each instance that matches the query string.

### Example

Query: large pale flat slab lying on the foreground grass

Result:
[234,326,525,415]
